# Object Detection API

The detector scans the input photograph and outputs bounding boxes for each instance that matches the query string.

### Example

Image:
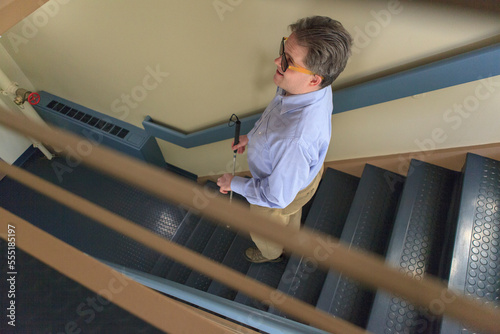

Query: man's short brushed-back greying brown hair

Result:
[290,16,352,88]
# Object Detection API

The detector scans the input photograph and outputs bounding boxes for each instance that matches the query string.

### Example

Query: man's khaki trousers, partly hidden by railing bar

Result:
[250,167,323,260]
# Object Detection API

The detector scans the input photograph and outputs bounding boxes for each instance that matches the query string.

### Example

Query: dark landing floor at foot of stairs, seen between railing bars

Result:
[0,152,185,272]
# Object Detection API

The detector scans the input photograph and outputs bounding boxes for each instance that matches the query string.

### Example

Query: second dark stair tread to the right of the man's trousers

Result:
[316,165,405,327]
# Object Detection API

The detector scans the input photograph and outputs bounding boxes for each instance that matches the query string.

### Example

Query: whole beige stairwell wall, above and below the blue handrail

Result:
[0,0,500,176]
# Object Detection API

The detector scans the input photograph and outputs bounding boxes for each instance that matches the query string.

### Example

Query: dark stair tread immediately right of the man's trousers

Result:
[269,168,359,317]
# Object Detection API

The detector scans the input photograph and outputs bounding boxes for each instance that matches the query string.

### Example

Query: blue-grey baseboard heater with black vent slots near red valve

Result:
[33,91,168,168]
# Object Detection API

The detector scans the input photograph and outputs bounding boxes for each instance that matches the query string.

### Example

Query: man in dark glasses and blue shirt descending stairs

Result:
[217,16,352,263]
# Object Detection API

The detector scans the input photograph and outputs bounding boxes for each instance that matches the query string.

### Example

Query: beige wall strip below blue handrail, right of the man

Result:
[327,76,500,160]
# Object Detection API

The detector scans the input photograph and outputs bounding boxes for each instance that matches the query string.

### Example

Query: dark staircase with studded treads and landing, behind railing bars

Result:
[0,154,500,334]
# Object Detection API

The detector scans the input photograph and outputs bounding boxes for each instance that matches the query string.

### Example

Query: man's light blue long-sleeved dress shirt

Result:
[231,86,333,208]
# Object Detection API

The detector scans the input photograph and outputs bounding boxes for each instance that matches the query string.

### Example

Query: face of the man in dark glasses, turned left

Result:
[273,33,321,95]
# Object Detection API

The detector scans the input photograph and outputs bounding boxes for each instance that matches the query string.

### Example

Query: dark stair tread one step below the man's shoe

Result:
[186,225,236,291]
